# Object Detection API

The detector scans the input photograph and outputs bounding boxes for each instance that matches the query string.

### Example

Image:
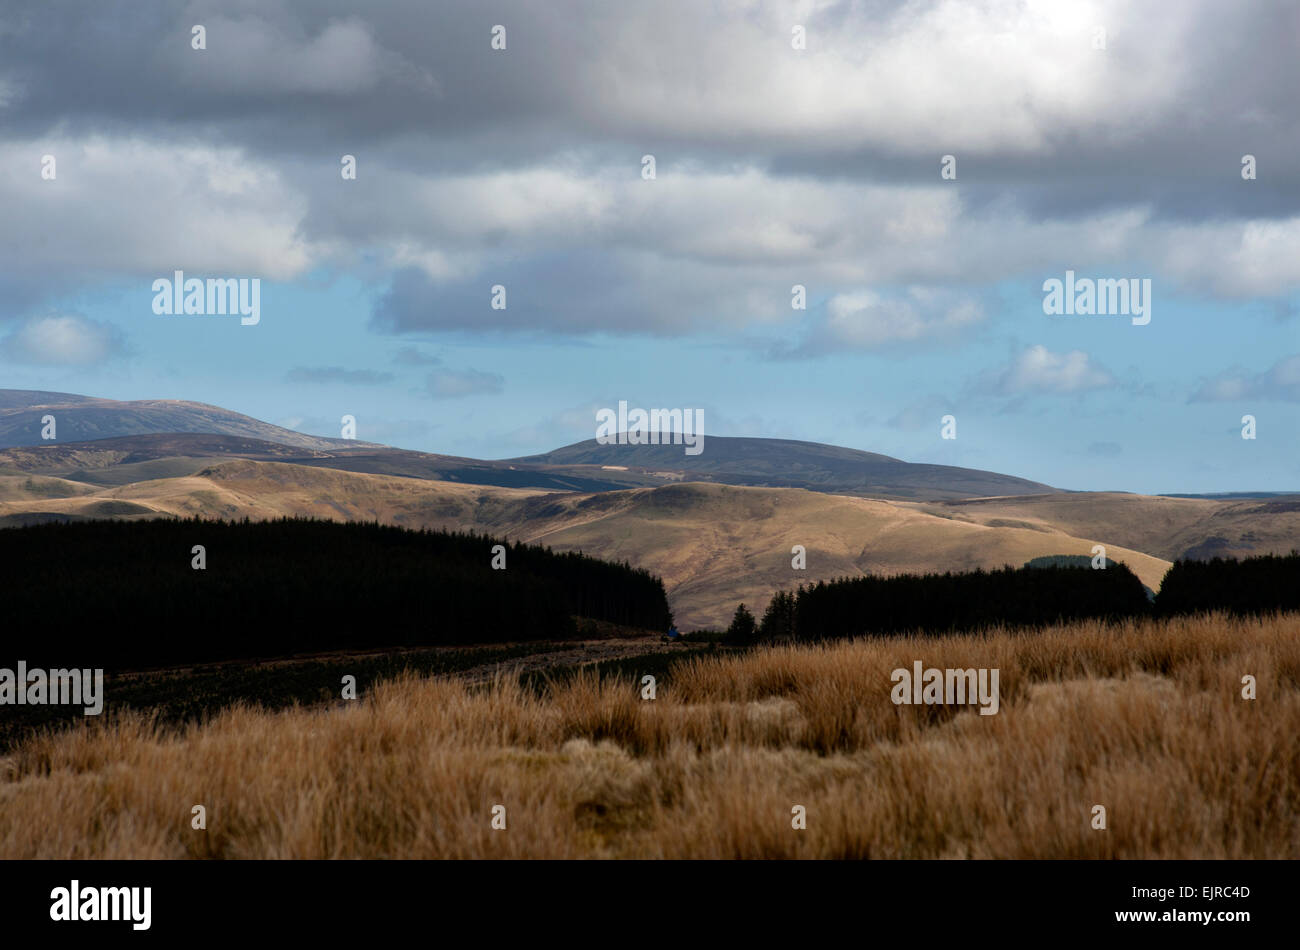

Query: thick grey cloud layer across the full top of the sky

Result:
[0,0,1300,218]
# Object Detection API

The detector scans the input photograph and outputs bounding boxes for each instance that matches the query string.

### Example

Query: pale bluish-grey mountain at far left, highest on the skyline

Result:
[0,390,368,448]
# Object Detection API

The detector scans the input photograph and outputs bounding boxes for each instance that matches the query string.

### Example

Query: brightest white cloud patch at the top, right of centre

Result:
[577,0,1199,151]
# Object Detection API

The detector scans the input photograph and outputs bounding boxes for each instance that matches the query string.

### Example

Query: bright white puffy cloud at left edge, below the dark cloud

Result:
[0,136,312,295]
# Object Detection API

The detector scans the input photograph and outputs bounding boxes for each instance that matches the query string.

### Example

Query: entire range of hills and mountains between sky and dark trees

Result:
[0,390,1300,629]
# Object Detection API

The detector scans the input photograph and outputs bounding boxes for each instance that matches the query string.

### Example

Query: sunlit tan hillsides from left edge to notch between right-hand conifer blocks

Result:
[0,460,1169,628]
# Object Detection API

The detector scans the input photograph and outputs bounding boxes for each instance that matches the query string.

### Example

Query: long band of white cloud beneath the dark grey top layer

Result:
[0,138,1300,346]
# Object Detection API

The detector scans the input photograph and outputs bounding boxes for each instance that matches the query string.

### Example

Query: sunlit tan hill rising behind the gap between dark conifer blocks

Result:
[525,485,1170,626]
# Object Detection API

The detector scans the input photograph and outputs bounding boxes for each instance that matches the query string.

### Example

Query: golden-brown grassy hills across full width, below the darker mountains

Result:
[0,454,1300,628]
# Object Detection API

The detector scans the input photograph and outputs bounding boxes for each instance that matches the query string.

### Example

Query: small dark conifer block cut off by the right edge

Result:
[1156,551,1300,616]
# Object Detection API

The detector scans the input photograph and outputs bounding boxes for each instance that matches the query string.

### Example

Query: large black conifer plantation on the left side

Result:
[0,519,672,669]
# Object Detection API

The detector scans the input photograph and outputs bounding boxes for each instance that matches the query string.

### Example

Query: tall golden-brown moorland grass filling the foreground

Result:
[0,615,1300,858]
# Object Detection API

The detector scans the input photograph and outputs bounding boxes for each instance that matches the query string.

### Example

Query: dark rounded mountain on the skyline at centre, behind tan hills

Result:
[507,435,1057,499]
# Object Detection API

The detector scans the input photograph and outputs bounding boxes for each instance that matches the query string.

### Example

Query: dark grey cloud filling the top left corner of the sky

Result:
[0,0,598,161]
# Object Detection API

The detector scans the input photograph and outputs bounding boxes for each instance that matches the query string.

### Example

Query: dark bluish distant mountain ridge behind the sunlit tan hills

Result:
[0,390,1058,500]
